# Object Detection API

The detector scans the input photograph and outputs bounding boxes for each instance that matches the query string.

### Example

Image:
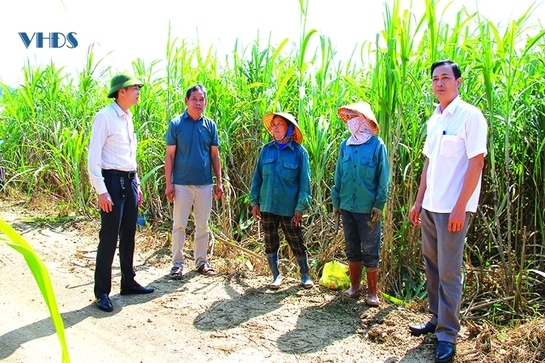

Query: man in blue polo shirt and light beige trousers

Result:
[165,84,223,280]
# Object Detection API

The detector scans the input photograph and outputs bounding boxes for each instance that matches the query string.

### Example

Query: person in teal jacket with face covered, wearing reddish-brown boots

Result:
[331,102,390,306]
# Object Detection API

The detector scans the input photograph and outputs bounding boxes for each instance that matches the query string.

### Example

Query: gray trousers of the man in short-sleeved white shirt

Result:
[421,209,469,343]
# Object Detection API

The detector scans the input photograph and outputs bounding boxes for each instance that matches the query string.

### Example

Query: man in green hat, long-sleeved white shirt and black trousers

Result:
[88,73,153,312]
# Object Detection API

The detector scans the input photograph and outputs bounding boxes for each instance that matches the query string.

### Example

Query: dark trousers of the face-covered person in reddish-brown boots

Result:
[341,209,382,267]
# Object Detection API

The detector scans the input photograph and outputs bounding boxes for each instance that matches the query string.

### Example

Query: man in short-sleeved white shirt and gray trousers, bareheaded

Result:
[409,60,487,363]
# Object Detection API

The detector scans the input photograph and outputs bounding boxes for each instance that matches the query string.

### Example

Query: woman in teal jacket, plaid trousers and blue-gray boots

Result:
[249,112,313,289]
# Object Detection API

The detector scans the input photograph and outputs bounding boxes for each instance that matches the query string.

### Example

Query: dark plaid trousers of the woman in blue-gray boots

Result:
[261,212,307,258]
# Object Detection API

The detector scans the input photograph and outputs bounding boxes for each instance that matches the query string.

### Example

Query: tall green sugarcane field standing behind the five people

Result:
[0,0,545,323]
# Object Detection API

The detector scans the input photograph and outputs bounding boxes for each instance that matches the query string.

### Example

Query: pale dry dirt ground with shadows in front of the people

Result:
[0,199,467,363]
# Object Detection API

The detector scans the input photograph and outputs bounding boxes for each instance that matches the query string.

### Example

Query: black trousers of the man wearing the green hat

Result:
[94,174,138,297]
